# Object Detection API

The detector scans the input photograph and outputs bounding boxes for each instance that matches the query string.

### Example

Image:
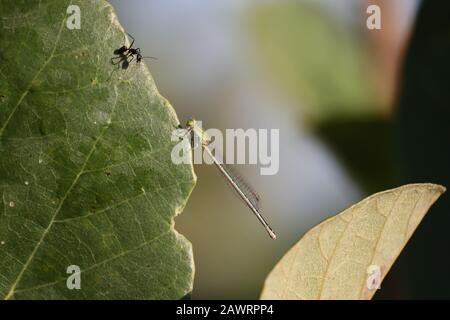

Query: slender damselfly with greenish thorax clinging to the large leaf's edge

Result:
[181,119,277,239]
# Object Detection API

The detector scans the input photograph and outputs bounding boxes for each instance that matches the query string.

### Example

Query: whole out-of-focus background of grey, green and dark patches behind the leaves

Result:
[110,0,450,299]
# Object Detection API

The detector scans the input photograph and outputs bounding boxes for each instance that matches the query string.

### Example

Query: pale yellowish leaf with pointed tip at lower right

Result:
[262,184,445,299]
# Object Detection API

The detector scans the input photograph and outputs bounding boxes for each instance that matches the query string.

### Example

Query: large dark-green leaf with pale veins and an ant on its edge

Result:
[0,0,195,299]
